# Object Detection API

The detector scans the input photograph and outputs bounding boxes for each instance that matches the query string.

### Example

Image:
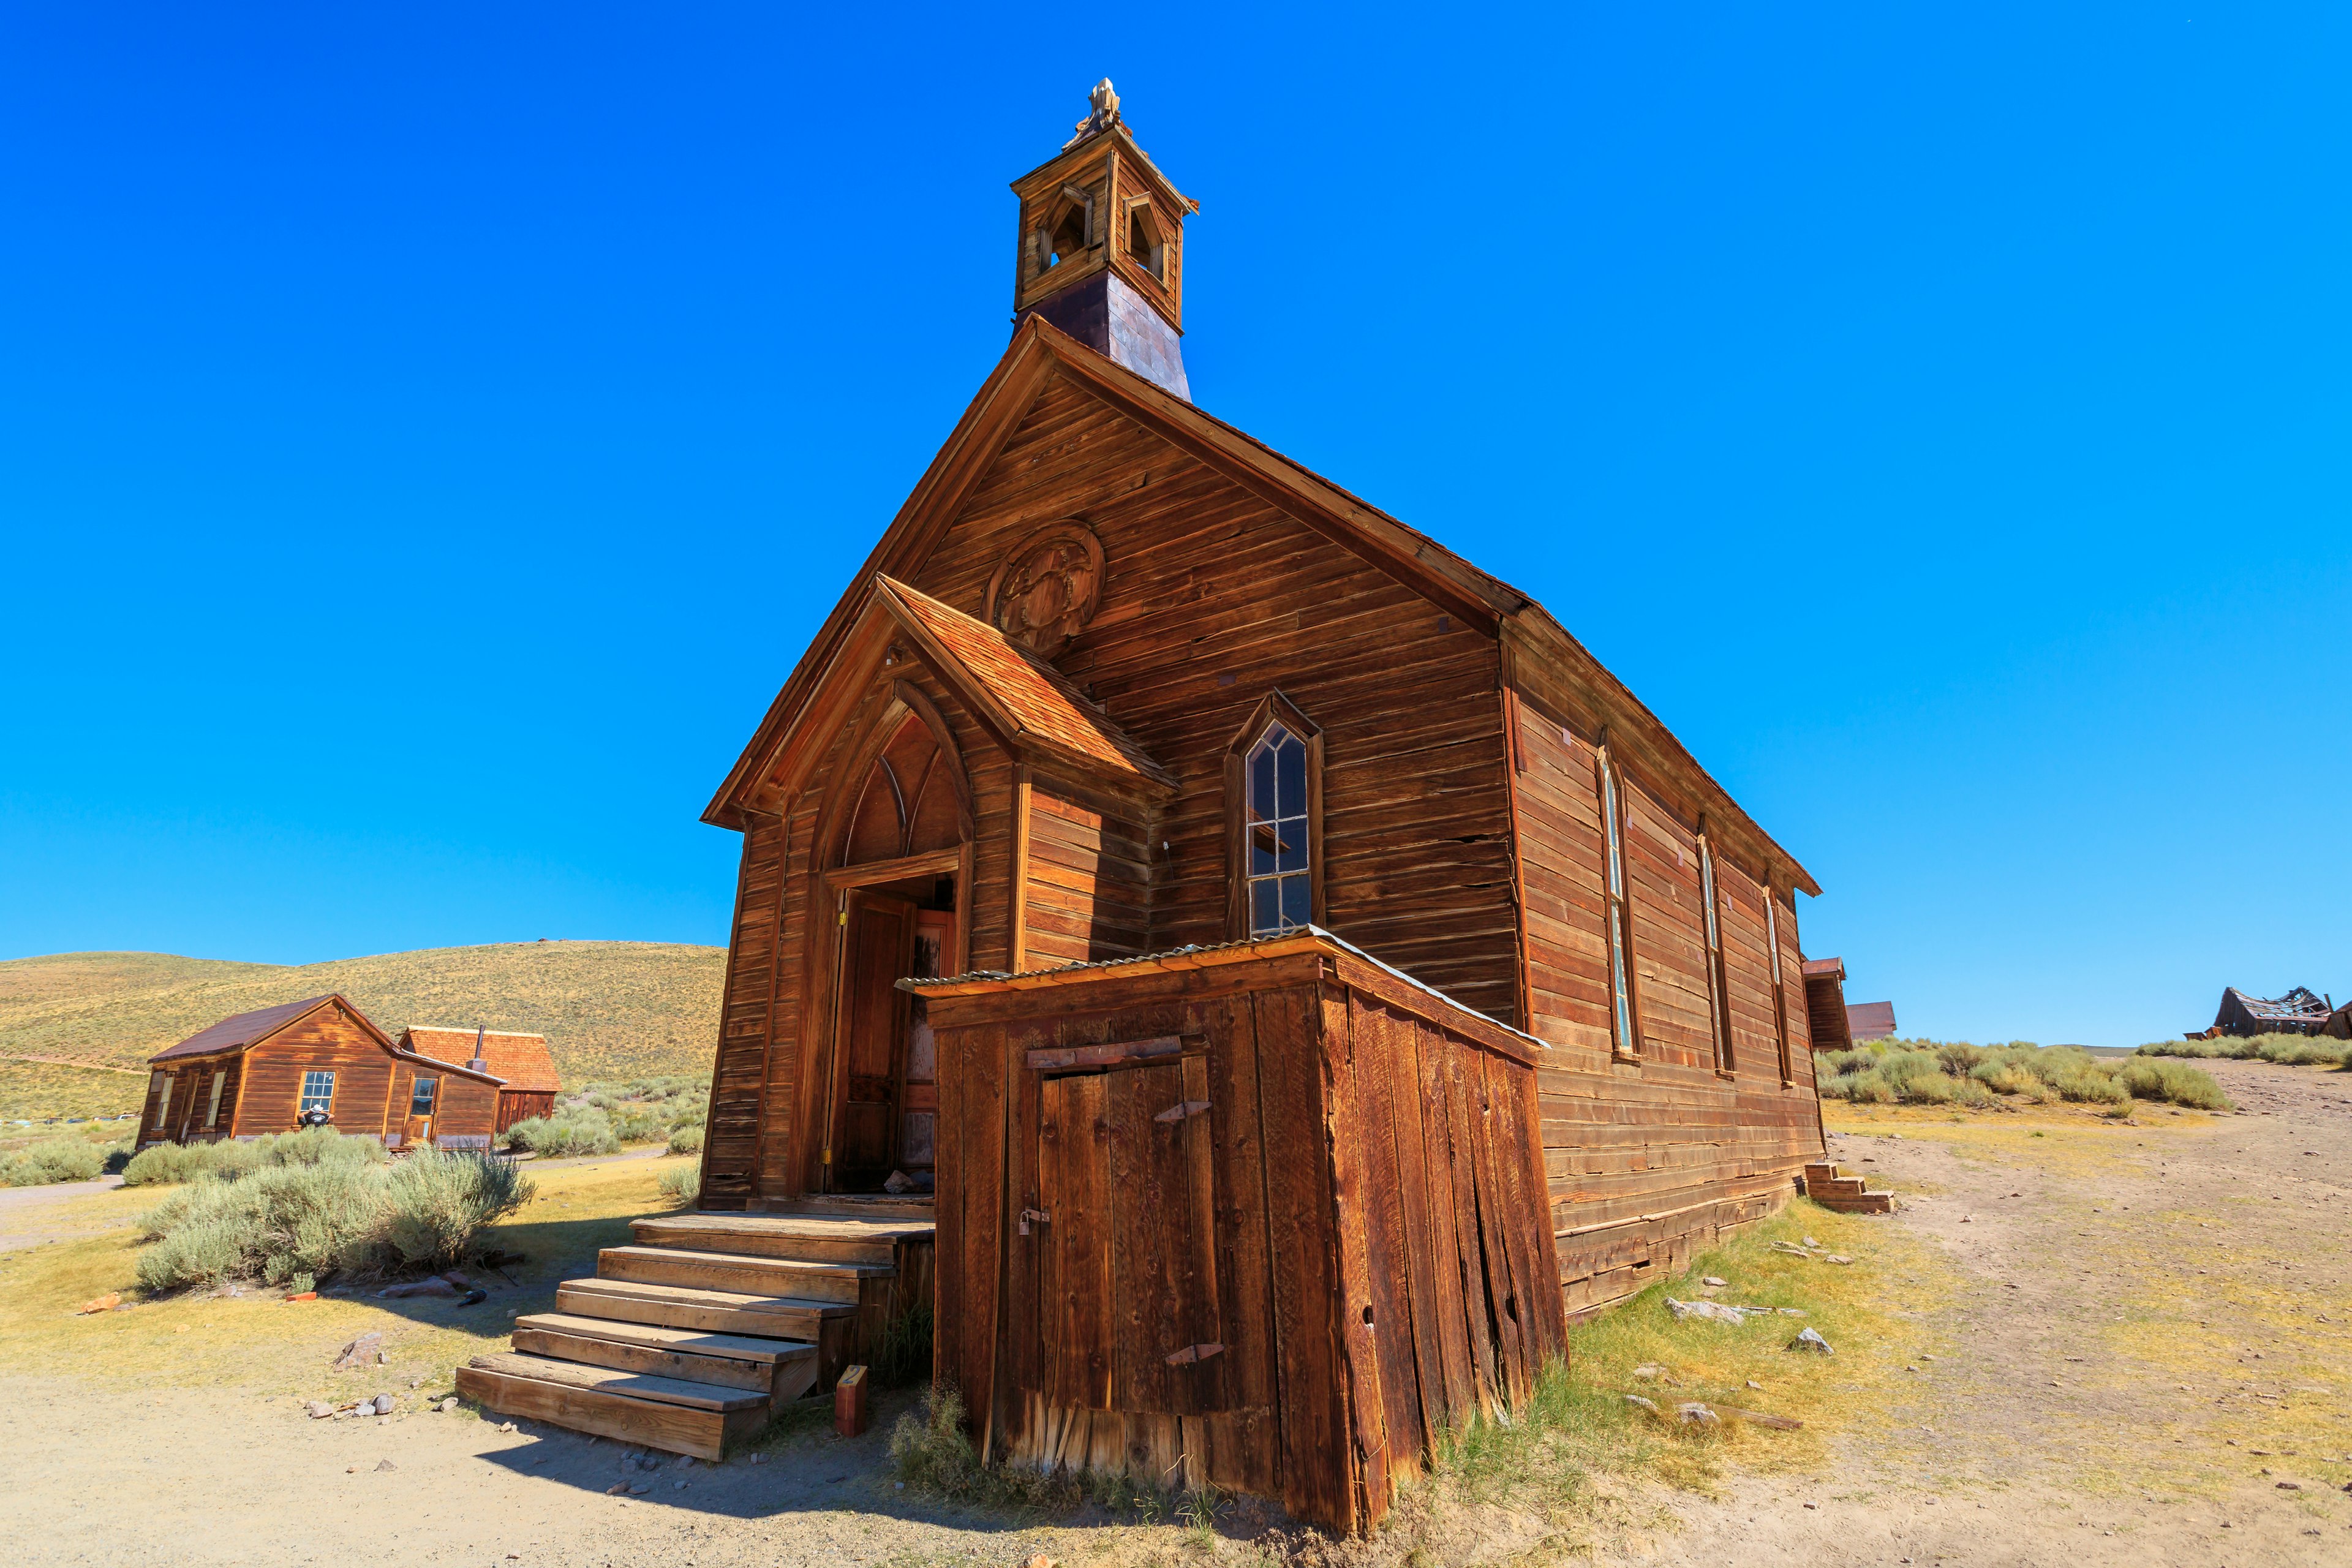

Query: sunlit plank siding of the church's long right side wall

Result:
[1515,691,1820,1314]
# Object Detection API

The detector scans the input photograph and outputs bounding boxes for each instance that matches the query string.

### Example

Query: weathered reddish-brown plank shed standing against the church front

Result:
[927,938,1566,1531]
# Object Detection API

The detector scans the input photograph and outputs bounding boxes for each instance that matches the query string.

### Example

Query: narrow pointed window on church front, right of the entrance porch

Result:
[1226,691,1327,938]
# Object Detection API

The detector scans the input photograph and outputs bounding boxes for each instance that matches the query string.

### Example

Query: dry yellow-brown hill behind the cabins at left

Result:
[0,943,727,1117]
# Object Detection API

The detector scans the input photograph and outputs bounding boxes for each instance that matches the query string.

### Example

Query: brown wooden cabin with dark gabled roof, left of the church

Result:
[139,995,499,1150]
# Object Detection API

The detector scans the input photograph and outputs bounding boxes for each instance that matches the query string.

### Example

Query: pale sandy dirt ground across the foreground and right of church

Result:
[0,1063,2352,1568]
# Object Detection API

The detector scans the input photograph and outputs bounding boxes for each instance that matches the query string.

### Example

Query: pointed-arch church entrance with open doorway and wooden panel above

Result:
[814,682,971,1192]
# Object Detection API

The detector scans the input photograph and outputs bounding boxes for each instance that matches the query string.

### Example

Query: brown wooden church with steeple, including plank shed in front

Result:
[454,82,1823,1531]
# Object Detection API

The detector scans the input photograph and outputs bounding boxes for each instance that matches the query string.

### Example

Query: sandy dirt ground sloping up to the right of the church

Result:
[1621,1063,2352,1568]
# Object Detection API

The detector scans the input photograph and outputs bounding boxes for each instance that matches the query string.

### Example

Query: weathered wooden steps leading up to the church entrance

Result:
[456,1197,932,1460]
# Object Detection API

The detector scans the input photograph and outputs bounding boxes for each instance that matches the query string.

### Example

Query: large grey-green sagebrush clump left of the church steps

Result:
[139,1140,532,1291]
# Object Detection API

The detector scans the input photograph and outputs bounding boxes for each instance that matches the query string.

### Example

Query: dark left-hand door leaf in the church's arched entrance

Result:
[826,891,915,1192]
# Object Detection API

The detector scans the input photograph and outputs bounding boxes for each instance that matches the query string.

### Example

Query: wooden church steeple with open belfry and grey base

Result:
[1014,78,1199,402]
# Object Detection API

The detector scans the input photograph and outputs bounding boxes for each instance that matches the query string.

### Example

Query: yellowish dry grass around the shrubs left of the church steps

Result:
[0,1159,682,1399]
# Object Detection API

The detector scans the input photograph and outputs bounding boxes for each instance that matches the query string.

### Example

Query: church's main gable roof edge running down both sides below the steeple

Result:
[703,315,1820,893]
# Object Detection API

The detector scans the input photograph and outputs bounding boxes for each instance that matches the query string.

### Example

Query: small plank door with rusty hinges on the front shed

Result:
[1037,1058,1227,1415]
